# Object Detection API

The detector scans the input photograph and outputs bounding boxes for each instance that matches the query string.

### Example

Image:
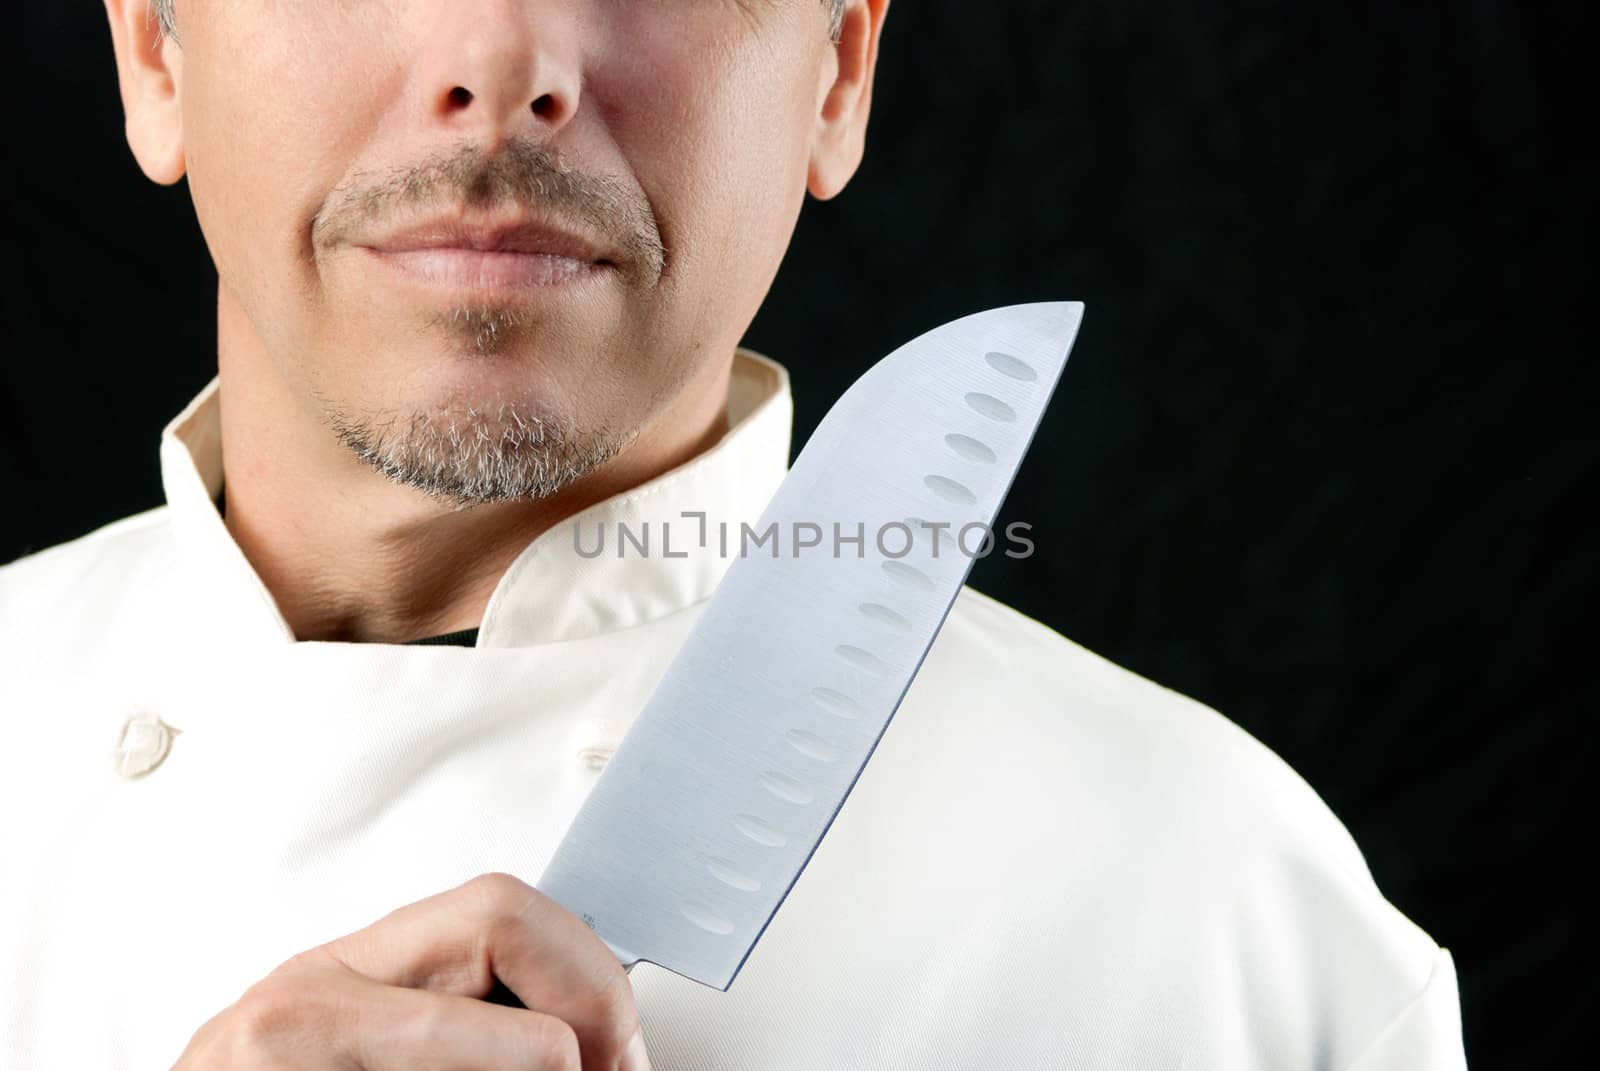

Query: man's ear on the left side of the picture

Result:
[104,0,184,186]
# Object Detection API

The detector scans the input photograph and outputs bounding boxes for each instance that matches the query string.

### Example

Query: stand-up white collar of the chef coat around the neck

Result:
[162,349,794,647]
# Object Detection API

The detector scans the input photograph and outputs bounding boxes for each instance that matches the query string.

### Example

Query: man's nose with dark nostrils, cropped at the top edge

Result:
[418,0,581,147]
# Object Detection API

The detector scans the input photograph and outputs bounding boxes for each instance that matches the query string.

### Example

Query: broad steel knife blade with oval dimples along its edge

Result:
[538,303,1083,991]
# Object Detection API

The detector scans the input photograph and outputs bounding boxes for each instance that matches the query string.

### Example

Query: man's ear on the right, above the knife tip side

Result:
[806,0,890,200]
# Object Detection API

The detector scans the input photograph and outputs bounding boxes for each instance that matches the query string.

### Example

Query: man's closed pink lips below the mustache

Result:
[357,219,616,293]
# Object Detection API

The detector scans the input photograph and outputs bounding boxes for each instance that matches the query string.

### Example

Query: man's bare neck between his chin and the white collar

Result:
[218,298,731,644]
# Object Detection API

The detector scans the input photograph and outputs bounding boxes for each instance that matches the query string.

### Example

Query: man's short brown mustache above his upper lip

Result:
[310,138,666,277]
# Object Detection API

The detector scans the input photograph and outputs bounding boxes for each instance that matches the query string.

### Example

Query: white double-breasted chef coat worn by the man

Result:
[0,351,1464,1071]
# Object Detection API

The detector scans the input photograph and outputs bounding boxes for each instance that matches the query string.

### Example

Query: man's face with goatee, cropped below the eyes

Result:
[145,0,857,503]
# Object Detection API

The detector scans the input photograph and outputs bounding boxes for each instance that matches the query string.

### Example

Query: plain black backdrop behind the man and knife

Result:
[0,0,1597,1068]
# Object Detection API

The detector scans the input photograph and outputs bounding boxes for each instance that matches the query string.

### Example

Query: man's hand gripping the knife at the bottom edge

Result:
[173,874,650,1071]
